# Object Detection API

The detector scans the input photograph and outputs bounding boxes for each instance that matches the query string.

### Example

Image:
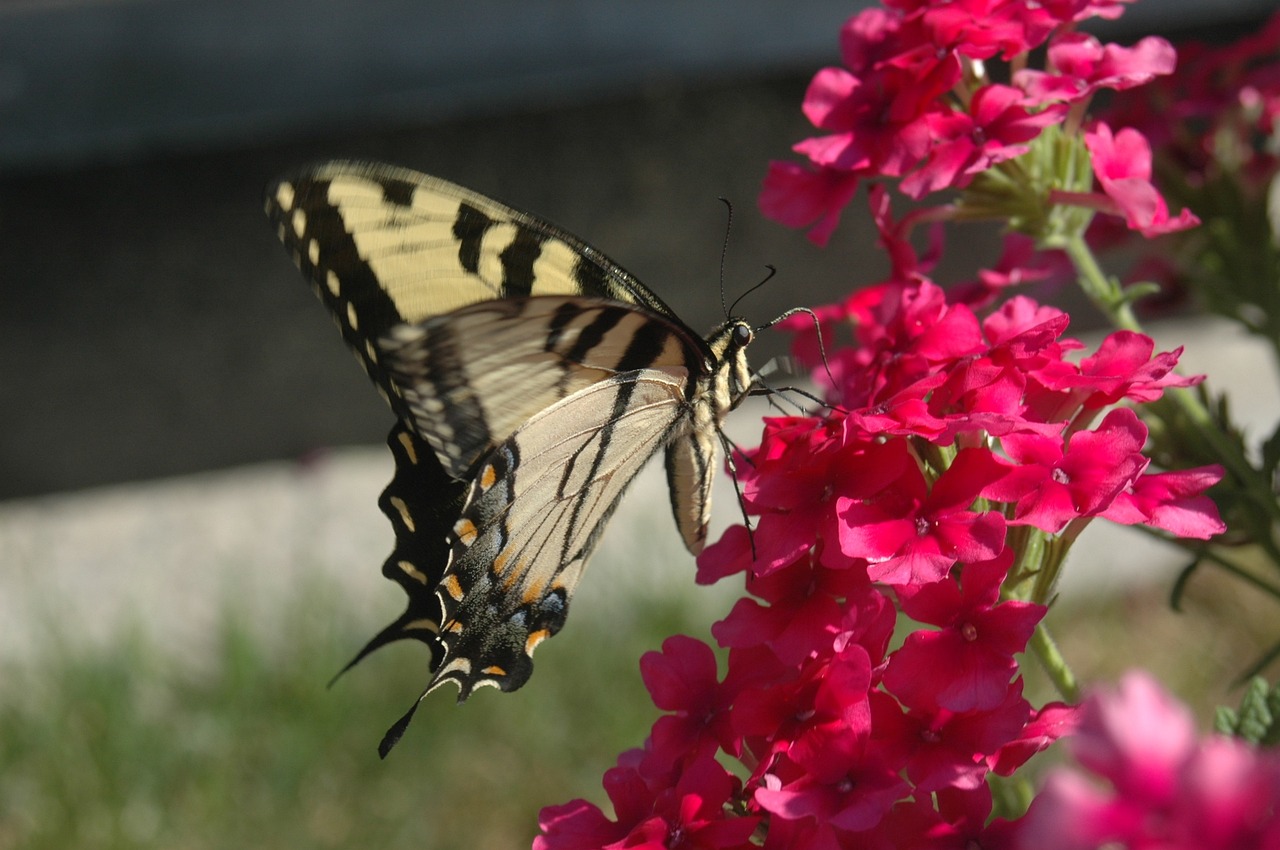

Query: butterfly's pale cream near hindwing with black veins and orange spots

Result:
[428,369,685,696]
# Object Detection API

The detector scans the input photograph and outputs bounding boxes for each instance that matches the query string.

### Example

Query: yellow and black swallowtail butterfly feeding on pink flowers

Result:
[266,161,759,757]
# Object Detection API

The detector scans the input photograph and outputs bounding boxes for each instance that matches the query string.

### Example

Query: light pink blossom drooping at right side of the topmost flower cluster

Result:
[1084,122,1199,237]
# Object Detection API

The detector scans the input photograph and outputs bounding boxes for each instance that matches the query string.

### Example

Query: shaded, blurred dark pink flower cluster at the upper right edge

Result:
[1088,12,1280,295]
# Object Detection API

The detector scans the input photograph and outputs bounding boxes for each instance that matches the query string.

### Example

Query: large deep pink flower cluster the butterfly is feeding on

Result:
[535,279,1222,850]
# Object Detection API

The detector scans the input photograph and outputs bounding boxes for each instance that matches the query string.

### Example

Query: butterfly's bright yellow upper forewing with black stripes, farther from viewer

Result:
[266,161,696,325]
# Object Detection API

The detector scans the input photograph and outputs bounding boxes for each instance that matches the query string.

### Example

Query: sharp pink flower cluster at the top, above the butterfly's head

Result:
[760,0,1198,245]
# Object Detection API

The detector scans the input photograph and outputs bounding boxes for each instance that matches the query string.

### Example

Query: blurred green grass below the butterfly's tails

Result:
[0,589,707,850]
